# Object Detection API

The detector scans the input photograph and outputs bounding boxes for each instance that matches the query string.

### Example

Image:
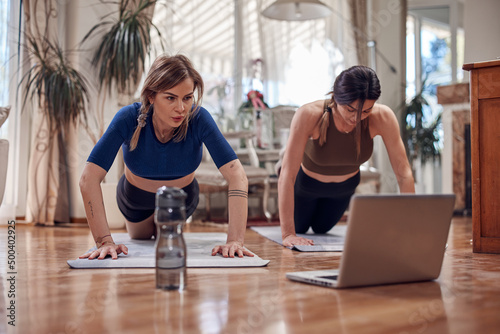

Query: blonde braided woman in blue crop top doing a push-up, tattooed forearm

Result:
[80,55,253,259]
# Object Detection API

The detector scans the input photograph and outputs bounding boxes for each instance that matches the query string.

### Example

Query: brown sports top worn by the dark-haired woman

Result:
[302,101,373,175]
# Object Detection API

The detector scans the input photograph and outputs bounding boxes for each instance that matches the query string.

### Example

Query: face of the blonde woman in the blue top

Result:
[150,78,194,129]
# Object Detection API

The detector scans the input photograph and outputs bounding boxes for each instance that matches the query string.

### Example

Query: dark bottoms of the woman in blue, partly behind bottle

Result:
[116,175,200,223]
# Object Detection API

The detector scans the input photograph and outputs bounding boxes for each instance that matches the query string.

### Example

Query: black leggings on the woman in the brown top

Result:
[294,168,360,234]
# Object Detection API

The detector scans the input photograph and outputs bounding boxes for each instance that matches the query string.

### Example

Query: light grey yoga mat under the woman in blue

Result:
[67,233,269,269]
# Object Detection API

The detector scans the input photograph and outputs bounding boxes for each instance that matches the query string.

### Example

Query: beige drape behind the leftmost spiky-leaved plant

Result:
[24,0,69,225]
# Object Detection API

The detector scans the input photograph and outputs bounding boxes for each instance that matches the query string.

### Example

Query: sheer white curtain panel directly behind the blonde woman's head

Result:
[147,0,237,127]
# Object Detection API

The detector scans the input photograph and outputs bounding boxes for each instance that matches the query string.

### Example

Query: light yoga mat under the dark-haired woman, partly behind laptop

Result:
[251,224,347,252]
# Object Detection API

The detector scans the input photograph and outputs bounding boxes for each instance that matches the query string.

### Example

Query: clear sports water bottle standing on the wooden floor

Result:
[155,186,187,290]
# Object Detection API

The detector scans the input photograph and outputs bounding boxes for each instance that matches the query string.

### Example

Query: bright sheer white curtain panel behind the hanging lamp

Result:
[243,0,358,105]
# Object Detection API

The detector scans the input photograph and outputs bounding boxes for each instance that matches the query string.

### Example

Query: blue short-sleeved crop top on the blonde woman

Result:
[87,103,237,180]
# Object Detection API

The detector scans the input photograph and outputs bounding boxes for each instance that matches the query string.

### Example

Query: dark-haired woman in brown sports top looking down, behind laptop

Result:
[278,66,415,247]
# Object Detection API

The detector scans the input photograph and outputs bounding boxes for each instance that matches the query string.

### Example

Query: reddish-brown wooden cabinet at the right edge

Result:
[463,60,500,254]
